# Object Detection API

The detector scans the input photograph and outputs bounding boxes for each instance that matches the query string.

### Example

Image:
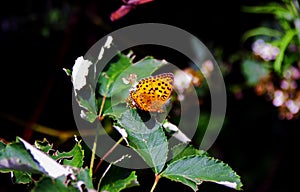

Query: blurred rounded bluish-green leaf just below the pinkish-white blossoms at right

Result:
[242,60,270,86]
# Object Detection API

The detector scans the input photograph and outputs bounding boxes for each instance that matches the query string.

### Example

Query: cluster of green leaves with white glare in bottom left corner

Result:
[0,138,93,192]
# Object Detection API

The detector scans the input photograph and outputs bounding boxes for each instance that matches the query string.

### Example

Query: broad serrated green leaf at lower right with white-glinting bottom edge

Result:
[161,155,242,191]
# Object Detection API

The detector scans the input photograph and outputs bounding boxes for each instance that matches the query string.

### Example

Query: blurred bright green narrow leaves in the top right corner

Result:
[242,1,300,75]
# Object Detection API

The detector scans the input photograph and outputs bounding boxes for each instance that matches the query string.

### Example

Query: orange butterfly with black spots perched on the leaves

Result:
[130,73,174,113]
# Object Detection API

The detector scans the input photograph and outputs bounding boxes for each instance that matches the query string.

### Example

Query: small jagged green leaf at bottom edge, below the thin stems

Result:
[100,166,139,192]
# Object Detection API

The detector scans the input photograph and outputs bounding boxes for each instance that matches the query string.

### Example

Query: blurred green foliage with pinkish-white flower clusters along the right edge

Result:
[231,0,300,120]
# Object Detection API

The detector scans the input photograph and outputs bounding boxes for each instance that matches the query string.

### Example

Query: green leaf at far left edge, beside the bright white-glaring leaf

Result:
[0,142,45,173]
